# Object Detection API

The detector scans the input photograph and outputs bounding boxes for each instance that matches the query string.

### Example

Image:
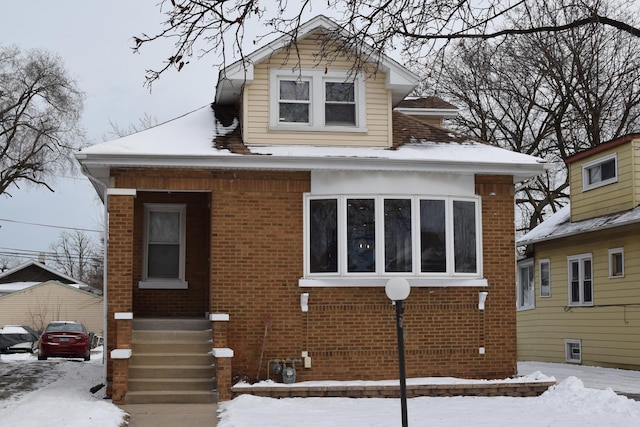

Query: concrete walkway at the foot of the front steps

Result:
[121,403,218,427]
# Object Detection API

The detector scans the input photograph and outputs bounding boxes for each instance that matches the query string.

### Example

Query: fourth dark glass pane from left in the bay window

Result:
[420,200,447,273]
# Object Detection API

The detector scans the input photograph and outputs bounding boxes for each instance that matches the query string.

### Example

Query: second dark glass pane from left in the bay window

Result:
[347,199,376,273]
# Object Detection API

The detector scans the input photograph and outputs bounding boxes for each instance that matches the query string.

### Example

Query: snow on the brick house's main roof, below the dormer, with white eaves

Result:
[76,106,544,186]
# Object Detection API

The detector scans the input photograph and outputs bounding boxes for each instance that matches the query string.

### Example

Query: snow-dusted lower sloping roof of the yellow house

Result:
[516,204,640,246]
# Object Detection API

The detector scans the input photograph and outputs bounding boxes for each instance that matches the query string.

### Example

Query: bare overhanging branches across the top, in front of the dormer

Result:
[134,0,640,85]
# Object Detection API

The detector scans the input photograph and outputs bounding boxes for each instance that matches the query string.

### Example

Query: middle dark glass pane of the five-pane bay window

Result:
[384,199,413,272]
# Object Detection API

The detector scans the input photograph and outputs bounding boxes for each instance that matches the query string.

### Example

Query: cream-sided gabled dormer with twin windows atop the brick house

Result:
[216,16,418,148]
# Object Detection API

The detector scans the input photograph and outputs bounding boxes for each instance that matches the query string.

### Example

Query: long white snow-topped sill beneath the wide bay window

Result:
[298,276,489,288]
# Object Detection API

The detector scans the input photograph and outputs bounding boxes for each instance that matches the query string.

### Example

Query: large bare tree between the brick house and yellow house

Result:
[436,0,640,231]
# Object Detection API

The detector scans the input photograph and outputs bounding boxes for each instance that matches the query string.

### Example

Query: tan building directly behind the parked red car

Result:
[0,280,104,335]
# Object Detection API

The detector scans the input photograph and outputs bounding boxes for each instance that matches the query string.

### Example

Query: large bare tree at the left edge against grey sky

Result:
[0,46,84,196]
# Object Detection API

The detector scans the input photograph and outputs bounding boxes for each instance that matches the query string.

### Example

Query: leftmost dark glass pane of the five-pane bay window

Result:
[309,199,338,273]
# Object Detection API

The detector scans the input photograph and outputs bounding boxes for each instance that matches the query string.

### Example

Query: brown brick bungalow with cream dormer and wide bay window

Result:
[77,16,545,403]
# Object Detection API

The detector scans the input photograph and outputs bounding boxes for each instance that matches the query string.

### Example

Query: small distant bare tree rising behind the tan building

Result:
[50,230,103,289]
